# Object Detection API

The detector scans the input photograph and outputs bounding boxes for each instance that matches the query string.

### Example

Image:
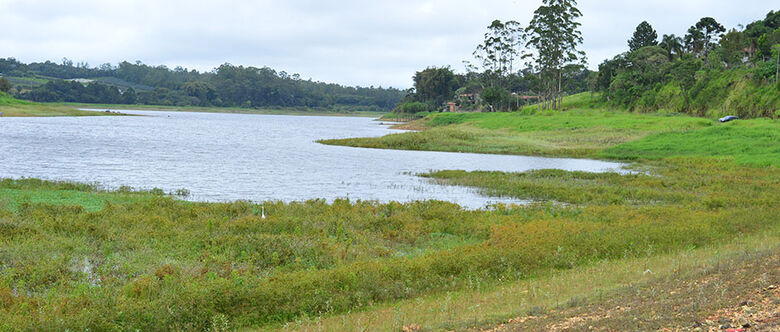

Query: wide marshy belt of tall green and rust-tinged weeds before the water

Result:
[0,154,780,330]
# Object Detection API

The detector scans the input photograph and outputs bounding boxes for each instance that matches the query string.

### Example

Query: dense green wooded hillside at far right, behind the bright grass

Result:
[589,11,780,116]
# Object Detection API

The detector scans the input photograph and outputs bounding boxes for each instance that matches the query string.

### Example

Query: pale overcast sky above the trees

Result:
[0,0,780,89]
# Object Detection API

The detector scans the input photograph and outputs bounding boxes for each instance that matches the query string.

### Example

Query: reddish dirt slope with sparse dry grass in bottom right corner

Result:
[483,248,780,332]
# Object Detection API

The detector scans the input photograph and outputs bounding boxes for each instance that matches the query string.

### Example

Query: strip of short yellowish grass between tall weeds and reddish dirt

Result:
[278,230,780,331]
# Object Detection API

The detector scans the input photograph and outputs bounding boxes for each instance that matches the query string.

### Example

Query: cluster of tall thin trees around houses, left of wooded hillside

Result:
[396,0,594,113]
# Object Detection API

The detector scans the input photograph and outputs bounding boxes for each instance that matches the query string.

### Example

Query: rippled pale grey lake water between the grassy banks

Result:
[0,111,621,208]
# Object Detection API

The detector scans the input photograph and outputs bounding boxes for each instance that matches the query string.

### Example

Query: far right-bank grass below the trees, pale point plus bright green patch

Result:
[320,94,780,166]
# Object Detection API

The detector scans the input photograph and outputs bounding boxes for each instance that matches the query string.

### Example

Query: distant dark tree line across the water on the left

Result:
[0,58,405,111]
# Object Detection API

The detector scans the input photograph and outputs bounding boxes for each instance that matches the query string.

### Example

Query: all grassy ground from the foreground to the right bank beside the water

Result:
[0,94,780,331]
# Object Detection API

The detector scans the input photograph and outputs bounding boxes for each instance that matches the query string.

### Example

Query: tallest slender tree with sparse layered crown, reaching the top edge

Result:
[526,0,585,109]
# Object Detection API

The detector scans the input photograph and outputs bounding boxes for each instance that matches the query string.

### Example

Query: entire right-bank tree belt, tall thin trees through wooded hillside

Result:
[395,0,780,116]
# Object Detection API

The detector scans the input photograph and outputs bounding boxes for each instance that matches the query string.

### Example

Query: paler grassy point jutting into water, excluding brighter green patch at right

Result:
[320,95,716,158]
